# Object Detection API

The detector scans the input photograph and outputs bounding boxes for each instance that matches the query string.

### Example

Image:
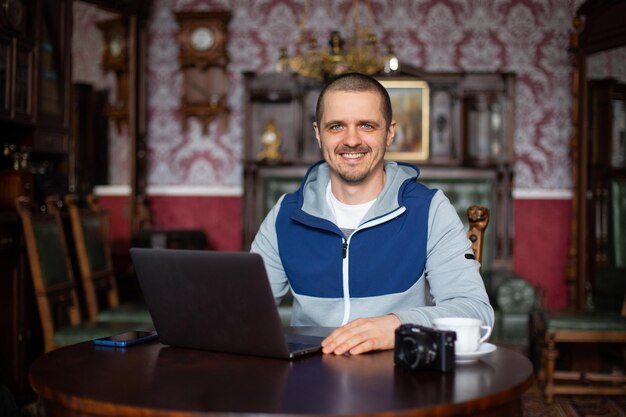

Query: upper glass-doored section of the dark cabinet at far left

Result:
[0,0,72,208]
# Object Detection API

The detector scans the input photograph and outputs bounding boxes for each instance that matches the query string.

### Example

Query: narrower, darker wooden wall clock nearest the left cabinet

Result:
[98,18,129,131]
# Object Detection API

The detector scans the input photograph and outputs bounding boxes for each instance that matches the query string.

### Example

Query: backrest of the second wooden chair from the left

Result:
[64,194,119,321]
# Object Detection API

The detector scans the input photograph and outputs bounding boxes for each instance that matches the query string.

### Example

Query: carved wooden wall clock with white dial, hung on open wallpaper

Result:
[176,11,231,134]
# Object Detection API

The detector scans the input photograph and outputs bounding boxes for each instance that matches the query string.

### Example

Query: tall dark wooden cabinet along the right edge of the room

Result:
[566,0,626,311]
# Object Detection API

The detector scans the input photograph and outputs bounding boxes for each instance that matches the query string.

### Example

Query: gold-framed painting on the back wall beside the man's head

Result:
[380,80,430,162]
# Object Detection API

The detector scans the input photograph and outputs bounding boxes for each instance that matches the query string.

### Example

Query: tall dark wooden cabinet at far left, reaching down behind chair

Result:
[0,0,72,405]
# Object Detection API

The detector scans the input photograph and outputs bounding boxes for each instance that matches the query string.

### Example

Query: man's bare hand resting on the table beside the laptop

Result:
[322,314,400,355]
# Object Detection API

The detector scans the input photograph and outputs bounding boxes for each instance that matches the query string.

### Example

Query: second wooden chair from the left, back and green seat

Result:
[64,194,152,323]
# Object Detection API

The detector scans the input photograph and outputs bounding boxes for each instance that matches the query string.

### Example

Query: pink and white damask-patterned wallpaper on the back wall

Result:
[75,0,582,190]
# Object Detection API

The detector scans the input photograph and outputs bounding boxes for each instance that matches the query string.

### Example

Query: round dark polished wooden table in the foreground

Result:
[30,328,532,417]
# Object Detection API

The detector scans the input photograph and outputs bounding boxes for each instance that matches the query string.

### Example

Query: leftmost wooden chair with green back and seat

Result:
[15,197,146,352]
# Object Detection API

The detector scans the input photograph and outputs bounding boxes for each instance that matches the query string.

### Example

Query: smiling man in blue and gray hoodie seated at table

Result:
[252,73,493,355]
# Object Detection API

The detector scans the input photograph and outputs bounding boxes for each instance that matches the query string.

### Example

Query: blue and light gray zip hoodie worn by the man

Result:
[251,161,494,327]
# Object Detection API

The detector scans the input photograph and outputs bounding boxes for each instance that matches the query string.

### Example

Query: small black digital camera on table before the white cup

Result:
[394,324,456,372]
